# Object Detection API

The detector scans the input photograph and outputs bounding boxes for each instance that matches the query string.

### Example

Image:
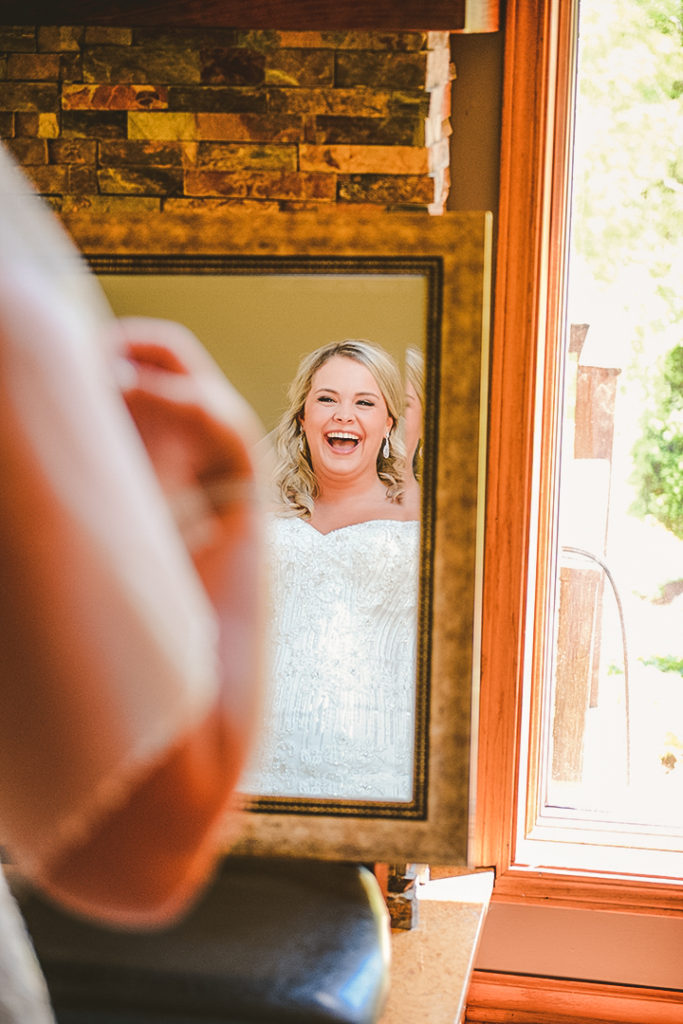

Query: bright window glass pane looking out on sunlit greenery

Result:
[544,0,683,831]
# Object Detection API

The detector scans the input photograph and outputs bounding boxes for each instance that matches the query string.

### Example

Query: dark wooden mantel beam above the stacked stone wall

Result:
[2,0,499,32]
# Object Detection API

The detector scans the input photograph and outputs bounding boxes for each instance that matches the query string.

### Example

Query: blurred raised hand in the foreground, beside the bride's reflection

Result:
[112,317,258,597]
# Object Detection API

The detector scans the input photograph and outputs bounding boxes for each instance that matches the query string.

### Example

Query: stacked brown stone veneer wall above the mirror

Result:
[0,26,452,215]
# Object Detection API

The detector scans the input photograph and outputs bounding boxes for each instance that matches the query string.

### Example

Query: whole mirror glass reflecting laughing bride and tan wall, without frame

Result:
[95,257,434,813]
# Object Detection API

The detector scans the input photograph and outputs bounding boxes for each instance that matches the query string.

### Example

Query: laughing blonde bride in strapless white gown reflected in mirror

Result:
[241,340,420,801]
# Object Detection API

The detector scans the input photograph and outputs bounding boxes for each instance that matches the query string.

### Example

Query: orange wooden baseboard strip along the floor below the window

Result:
[465,971,683,1024]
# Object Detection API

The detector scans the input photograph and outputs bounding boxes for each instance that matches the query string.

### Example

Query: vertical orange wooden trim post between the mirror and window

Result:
[474,0,556,873]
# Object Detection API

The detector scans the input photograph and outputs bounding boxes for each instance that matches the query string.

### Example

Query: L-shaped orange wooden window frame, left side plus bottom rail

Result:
[474,0,683,913]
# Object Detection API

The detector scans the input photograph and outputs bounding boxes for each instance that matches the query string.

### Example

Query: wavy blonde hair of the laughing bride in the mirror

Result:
[274,338,405,518]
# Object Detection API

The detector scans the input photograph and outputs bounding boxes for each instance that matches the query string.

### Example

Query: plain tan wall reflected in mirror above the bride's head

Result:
[100,274,428,432]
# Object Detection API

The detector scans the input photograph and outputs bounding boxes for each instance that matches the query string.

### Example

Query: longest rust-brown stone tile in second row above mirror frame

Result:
[185,171,336,203]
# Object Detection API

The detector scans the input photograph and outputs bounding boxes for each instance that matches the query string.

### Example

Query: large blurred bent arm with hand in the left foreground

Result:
[0,142,261,926]
